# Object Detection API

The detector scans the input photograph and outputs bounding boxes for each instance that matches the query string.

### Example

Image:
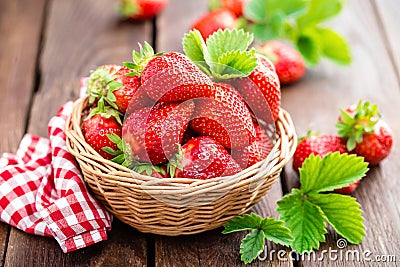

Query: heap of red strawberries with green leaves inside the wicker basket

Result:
[82,30,281,179]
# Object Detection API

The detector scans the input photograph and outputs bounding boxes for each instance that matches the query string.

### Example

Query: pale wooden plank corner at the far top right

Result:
[372,0,400,83]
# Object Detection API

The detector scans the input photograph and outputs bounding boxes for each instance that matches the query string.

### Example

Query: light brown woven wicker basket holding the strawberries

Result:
[66,98,297,236]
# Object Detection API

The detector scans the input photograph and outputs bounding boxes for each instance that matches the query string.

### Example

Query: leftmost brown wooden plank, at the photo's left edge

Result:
[0,0,45,266]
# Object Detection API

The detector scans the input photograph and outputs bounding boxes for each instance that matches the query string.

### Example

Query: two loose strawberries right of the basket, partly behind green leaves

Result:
[293,101,393,194]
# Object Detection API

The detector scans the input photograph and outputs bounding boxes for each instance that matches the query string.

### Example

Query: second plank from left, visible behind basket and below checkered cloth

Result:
[6,0,152,266]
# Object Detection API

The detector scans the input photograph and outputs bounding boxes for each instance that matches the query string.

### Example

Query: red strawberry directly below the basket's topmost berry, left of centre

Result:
[122,100,194,164]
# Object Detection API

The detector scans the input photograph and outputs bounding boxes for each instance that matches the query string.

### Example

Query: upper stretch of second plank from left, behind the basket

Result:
[28,0,152,138]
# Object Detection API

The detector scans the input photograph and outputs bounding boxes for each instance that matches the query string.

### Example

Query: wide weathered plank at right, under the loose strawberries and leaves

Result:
[283,1,400,266]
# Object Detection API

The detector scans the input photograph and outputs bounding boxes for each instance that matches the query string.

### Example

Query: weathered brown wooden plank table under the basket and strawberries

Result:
[0,0,400,267]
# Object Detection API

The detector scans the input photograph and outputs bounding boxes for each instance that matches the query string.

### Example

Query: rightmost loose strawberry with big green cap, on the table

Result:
[336,101,393,164]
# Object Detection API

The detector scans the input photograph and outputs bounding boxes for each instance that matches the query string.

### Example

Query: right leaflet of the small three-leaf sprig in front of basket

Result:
[261,218,293,246]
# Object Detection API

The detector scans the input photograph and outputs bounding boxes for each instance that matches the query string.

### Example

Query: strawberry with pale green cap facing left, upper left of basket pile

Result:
[87,65,145,113]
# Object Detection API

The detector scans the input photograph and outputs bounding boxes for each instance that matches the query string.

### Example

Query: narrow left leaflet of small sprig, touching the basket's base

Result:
[222,213,263,234]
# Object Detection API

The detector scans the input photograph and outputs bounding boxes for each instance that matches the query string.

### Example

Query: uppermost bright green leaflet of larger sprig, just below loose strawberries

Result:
[300,152,368,193]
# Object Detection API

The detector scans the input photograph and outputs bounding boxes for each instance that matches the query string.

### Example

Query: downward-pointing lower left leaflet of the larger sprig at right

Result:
[278,189,327,254]
